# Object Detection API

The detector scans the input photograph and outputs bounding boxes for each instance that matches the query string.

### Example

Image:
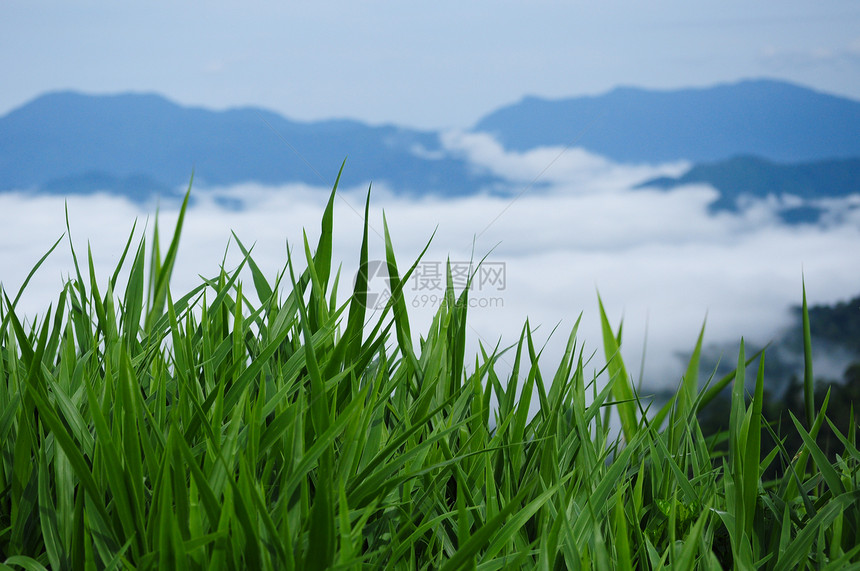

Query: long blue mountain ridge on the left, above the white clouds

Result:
[0,92,497,201]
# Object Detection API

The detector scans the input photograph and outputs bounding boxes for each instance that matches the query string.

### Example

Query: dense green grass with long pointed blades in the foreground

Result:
[0,175,860,571]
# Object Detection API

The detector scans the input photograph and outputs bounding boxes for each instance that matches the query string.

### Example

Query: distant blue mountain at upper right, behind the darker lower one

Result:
[473,80,860,163]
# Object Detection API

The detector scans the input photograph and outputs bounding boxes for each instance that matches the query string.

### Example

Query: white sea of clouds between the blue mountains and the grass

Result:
[0,139,860,396]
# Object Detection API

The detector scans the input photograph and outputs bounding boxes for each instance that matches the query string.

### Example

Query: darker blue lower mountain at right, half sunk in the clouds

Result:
[637,156,860,222]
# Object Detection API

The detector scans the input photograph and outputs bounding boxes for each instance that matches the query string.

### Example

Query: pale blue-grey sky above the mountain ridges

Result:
[0,0,860,128]
